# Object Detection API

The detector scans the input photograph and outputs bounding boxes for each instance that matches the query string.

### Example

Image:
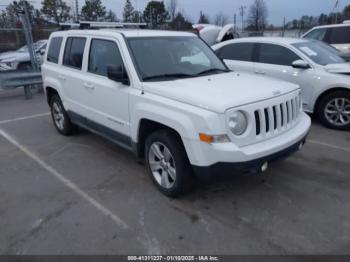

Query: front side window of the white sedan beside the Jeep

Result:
[258,44,300,66]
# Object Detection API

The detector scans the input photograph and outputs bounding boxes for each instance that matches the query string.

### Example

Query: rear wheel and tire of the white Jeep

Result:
[50,95,77,136]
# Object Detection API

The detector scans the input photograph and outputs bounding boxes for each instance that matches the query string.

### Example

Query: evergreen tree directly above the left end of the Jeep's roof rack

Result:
[41,0,71,24]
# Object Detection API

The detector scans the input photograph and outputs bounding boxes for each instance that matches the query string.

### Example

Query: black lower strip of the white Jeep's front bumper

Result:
[192,136,307,180]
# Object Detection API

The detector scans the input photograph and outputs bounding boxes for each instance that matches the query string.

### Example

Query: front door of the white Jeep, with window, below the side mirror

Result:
[83,37,130,138]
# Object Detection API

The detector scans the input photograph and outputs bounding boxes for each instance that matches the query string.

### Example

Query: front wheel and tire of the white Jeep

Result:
[145,130,193,198]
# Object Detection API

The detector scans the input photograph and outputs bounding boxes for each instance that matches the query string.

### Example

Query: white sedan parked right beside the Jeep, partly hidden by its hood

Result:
[213,37,350,130]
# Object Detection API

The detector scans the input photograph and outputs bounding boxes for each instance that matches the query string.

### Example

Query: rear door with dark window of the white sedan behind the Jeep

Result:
[217,43,255,73]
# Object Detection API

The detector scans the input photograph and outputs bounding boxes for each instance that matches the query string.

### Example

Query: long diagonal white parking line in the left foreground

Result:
[0,129,129,230]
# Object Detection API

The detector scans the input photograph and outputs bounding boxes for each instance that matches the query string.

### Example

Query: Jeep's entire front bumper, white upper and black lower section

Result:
[184,113,311,176]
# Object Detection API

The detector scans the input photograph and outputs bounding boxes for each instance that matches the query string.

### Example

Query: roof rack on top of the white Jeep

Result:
[60,21,147,30]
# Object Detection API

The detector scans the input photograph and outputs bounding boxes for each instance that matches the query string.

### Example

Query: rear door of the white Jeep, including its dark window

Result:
[61,37,88,116]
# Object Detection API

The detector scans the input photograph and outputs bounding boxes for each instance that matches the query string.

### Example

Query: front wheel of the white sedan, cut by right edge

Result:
[317,91,350,130]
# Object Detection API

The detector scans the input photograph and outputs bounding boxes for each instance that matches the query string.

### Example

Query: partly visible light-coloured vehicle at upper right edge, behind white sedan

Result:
[302,22,350,54]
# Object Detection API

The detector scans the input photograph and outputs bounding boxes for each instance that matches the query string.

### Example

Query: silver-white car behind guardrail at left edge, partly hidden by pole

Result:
[0,40,47,71]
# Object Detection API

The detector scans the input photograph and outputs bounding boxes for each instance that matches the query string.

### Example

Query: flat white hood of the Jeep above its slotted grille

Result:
[143,72,299,113]
